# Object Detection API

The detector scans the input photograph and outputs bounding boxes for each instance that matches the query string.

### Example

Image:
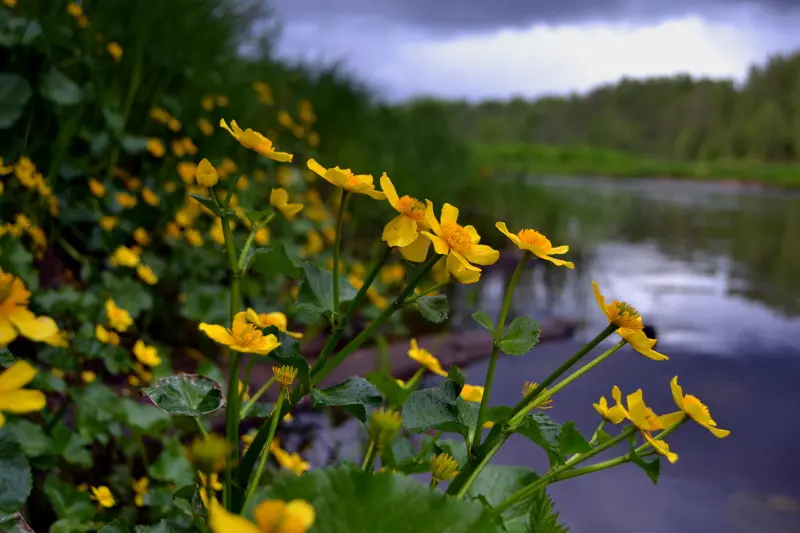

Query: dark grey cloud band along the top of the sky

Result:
[274,0,800,33]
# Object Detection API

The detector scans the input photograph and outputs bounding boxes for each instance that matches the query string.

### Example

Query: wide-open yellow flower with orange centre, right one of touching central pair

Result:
[422,201,500,283]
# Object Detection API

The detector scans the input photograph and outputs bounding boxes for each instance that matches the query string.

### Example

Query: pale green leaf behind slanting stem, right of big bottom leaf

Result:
[467,465,539,533]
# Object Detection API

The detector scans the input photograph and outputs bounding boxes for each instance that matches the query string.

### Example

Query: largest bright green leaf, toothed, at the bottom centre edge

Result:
[254,466,502,533]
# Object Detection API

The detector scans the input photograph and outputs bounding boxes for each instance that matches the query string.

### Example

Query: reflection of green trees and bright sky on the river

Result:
[454,178,800,355]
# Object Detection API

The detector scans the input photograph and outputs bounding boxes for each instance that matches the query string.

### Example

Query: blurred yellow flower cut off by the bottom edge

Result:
[208,500,316,533]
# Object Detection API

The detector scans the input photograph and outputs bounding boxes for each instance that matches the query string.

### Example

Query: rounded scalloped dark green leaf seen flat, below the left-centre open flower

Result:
[142,374,225,416]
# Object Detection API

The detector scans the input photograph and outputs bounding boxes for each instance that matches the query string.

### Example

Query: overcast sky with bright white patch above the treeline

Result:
[273,0,800,100]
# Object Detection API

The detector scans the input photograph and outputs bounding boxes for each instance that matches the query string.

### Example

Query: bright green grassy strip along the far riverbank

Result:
[472,143,800,189]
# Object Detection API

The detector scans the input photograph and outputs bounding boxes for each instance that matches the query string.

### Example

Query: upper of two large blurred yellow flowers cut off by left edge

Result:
[0,270,58,347]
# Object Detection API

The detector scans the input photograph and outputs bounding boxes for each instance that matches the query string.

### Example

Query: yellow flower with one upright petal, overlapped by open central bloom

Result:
[381,172,431,263]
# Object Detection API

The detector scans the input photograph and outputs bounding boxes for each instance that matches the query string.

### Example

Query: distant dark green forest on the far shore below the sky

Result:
[410,51,800,162]
